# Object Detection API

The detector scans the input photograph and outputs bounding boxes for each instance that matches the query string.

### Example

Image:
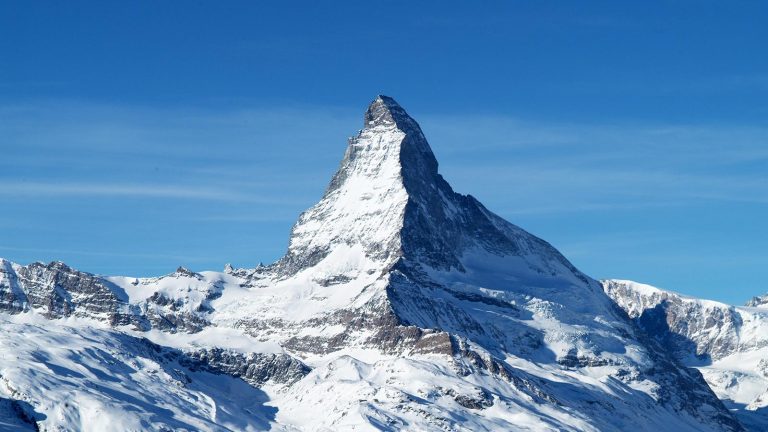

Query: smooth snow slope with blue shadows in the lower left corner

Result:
[0,313,274,432]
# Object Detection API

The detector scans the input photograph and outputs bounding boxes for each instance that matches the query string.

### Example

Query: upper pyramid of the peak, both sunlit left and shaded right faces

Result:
[277,96,584,284]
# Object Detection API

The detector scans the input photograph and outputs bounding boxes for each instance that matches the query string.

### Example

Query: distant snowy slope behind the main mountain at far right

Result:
[603,280,768,431]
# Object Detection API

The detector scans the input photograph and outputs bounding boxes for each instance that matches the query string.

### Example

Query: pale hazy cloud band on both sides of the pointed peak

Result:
[0,101,768,216]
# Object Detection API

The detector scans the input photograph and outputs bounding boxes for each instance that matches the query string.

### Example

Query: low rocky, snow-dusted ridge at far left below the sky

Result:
[0,260,222,333]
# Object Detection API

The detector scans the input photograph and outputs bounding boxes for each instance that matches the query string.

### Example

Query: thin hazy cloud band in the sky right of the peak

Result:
[423,116,768,215]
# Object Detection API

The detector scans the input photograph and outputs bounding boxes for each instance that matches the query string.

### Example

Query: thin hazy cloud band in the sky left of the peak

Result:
[0,101,357,209]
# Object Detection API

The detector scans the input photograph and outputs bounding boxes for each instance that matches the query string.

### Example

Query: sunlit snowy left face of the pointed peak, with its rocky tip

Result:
[278,96,420,275]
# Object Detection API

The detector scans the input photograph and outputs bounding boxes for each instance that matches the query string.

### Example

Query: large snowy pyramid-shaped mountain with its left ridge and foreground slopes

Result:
[0,96,744,432]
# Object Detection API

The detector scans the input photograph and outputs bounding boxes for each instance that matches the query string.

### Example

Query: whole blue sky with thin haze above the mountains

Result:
[0,1,768,304]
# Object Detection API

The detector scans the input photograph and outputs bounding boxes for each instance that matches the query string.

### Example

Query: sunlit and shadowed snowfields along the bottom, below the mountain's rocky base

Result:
[0,312,732,432]
